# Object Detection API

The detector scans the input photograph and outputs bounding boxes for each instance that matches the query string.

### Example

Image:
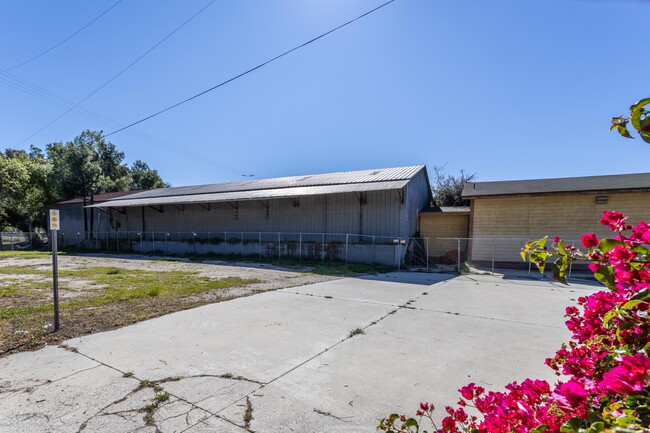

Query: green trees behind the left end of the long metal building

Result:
[0,130,168,231]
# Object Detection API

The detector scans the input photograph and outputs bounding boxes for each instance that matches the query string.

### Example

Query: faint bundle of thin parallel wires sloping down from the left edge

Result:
[0,72,245,176]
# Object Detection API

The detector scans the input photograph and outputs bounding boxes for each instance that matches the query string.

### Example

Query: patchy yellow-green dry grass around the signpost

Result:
[0,254,260,355]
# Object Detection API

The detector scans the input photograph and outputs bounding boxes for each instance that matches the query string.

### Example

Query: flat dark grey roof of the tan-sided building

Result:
[463,173,650,198]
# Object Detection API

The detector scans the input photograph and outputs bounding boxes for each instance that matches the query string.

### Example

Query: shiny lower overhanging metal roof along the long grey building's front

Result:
[88,180,409,207]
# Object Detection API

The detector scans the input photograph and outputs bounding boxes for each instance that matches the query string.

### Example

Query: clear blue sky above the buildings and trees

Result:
[0,0,650,186]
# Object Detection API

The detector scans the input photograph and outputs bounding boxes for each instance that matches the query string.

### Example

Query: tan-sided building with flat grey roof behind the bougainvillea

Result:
[463,173,650,265]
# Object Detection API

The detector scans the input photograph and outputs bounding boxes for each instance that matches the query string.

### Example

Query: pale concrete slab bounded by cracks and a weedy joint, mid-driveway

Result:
[63,292,388,382]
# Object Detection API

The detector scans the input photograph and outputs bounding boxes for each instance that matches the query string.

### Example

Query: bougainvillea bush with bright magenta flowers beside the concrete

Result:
[377,212,650,433]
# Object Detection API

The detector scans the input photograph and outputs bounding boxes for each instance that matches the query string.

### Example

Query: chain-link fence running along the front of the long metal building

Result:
[0,231,580,272]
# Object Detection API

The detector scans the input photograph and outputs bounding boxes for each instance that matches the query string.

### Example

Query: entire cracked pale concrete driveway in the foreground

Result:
[0,273,599,433]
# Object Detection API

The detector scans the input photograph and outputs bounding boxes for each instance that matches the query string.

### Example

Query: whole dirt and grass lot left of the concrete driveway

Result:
[0,254,337,356]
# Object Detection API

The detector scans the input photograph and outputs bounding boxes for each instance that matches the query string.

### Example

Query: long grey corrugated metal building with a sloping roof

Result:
[83,166,431,264]
